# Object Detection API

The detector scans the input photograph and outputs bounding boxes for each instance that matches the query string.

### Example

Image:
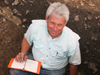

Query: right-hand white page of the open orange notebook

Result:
[25,59,38,72]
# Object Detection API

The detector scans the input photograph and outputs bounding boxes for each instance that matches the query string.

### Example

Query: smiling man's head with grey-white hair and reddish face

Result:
[46,2,69,38]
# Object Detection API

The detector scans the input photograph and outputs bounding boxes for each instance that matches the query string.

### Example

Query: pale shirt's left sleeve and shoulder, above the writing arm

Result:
[24,20,46,45]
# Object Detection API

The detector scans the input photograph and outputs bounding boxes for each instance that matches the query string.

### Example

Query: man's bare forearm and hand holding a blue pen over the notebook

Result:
[15,37,30,62]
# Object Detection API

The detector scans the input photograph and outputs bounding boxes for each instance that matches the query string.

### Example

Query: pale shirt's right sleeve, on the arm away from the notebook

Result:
[68,41,81,65]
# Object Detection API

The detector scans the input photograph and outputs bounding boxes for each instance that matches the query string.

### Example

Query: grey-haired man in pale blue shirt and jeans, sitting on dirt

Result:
[10,2,81,75]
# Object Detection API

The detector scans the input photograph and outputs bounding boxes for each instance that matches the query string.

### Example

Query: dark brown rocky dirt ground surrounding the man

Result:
[0,0,100,75]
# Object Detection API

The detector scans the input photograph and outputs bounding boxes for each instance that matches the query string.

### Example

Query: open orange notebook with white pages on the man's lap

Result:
[8,58,41,74]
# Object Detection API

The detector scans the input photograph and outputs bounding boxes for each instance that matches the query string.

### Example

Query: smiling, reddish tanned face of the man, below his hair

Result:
[46,14,66,39]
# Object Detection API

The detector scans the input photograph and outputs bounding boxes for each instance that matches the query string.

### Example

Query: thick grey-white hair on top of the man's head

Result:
[46,2,70,22]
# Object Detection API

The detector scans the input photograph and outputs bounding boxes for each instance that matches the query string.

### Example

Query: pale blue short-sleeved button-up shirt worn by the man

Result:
[24,20,81,70]
